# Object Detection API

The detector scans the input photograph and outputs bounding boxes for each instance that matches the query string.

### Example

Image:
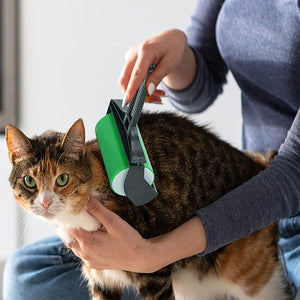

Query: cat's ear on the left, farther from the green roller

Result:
[5,125,32,163]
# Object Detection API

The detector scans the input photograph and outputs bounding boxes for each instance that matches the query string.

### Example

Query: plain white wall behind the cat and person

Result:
[0,0,241,257]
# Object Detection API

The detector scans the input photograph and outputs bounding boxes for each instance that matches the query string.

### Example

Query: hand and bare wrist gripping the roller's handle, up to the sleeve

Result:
[119,29,196,105]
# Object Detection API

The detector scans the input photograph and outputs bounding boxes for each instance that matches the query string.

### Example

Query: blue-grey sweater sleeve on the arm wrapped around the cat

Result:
[197,110,300,255]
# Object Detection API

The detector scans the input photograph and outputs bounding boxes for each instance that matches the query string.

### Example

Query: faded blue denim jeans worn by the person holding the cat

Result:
[3,232,300,300]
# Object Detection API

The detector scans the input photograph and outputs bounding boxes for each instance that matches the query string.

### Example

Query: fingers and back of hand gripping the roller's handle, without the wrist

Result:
[119,29,187,105]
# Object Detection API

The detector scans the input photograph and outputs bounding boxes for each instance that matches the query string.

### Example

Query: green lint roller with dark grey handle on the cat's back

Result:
[95,64,157,206]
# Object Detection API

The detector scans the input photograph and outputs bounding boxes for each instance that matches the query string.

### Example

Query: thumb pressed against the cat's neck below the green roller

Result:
[87,197,119,230]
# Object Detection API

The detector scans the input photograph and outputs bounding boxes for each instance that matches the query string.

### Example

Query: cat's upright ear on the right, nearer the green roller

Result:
[62,119,85,156]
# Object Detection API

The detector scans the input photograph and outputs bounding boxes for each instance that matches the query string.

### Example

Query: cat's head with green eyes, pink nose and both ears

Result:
[6,119,92,221]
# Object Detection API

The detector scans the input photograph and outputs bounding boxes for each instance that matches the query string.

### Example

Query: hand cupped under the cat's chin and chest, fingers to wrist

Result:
[68,198,149,272]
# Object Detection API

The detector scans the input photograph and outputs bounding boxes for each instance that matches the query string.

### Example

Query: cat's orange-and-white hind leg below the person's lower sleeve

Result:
[216,223,290,300]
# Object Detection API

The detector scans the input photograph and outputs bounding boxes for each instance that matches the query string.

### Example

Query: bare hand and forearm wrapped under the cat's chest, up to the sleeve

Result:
[69,198,206,273]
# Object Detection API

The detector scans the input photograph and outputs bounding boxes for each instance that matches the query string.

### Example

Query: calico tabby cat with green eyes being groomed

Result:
[6,113,291,300]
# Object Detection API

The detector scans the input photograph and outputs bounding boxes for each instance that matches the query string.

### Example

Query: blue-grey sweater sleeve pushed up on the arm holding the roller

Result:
[162,0,228,113]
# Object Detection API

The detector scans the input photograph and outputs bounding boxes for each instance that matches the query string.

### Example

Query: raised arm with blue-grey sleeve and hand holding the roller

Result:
[119,0,227,108]
